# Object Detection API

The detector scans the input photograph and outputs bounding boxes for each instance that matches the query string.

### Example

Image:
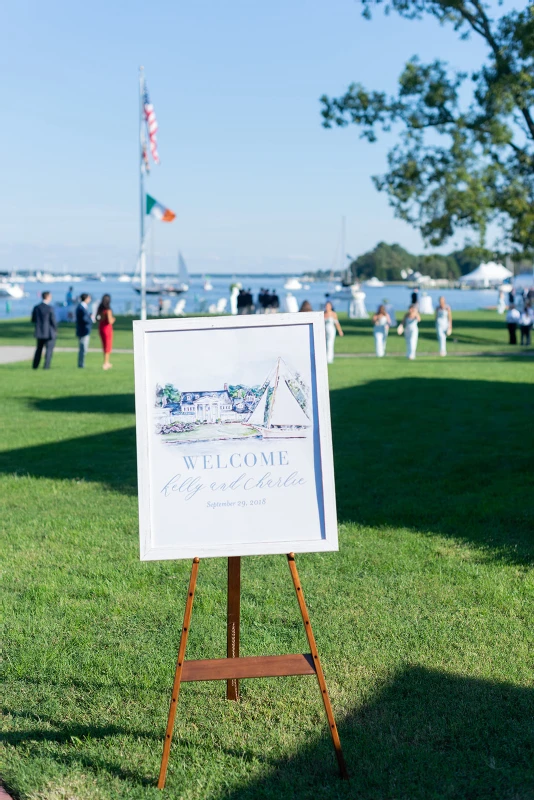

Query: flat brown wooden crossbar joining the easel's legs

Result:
[182,653,316,682]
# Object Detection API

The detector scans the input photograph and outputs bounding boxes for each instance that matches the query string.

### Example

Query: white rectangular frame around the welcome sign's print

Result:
[133,312,338,561]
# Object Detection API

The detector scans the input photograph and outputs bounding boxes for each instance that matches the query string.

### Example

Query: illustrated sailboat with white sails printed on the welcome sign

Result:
[244,358,311,439]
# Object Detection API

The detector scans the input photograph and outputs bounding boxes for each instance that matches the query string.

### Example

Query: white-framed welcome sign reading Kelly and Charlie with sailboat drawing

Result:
[134,313,337,560]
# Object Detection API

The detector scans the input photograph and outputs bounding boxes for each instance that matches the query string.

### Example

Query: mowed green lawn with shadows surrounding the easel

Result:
[0,354,534,800]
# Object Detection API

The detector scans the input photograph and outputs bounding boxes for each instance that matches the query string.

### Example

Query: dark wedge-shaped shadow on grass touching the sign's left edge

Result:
[0,428,137,495]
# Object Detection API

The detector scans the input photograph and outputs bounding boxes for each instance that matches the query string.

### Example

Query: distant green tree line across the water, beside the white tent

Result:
[350,242,499,281]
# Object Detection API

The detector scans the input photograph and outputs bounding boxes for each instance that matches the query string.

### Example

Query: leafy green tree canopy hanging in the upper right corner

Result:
[321,0,534,251]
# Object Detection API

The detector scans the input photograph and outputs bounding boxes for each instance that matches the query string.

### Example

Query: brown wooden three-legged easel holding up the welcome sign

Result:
[158,553,349,789]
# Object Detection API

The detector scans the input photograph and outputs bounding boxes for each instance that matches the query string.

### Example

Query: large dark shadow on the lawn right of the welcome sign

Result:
[331,376,534,563]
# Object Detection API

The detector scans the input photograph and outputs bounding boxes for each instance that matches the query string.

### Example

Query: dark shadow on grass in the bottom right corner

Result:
[220,667,534,800]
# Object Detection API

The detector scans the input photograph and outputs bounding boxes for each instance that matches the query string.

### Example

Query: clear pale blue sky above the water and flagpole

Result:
[0,0,498,274]
